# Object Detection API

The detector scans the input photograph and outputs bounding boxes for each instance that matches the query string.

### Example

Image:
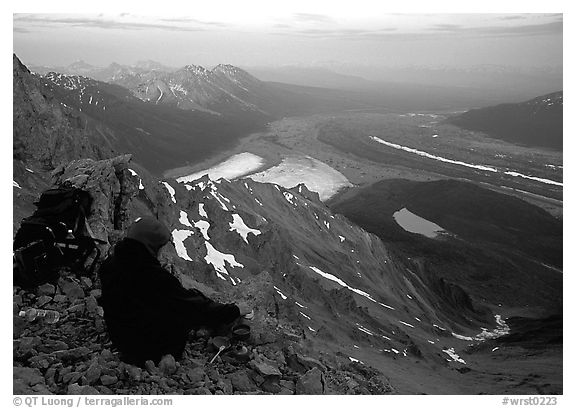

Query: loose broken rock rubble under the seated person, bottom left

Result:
[13,268,391,395]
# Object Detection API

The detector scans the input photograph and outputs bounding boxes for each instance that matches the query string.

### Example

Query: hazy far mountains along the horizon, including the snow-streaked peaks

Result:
[30,60,560,113]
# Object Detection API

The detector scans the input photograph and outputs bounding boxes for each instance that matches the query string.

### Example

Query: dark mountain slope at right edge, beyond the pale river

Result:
[448,91,563,150]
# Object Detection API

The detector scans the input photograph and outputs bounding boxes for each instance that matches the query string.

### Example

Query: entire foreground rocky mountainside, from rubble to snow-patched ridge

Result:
[14,152,520,393]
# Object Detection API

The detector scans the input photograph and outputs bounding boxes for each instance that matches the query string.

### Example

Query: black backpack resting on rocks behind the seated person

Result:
[13,187,101,288]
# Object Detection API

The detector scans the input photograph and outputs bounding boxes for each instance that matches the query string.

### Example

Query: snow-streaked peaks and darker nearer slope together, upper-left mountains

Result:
[13,55,370,174]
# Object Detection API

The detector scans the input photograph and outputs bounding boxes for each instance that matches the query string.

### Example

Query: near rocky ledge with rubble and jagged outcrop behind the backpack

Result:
[13,155,400,394]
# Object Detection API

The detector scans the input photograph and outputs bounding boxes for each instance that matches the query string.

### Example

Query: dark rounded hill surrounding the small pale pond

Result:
[330,180,562,314]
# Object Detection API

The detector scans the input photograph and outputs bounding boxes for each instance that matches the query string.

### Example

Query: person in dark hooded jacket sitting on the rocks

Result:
[99,218,240,364]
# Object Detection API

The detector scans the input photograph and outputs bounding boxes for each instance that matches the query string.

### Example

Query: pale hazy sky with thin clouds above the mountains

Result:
[13,5,563,67]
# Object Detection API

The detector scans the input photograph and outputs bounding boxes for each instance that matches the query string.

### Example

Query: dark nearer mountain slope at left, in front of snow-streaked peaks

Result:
[13,56,268,174]
